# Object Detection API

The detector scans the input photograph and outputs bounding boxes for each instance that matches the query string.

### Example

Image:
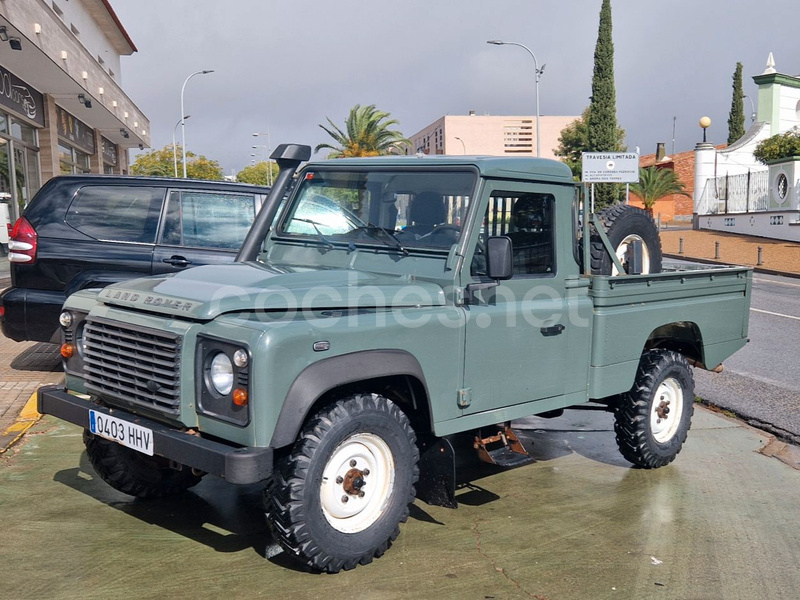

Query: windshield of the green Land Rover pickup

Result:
[278,169,476,252]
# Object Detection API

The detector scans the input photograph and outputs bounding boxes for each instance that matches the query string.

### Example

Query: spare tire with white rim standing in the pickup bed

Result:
[591,204,661,275]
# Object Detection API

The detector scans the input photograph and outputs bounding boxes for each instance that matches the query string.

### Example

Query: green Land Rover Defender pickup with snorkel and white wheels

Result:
[39,144,752,572]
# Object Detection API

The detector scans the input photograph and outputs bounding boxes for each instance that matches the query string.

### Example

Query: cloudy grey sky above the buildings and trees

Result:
[110,0,800,174]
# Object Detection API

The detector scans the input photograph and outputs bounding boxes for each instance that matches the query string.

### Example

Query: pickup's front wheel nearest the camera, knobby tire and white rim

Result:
[264,394,419,573]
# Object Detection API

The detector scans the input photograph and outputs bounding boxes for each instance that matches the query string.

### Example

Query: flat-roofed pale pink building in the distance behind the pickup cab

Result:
[409,112,580,158]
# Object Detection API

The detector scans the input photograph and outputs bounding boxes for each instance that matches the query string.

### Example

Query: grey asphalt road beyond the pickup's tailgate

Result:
[695,273,800,443]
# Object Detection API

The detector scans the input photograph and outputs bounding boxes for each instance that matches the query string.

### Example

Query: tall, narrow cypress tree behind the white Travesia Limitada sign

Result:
[588,0,625,208]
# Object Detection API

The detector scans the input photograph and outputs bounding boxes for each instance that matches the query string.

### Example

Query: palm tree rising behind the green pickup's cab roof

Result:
[314,104,411,158]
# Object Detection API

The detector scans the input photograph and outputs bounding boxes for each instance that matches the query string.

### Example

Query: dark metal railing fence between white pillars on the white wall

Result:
[697,170,769,215]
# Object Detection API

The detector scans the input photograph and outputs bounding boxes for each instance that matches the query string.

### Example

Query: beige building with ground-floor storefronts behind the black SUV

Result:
[0,0,150,222]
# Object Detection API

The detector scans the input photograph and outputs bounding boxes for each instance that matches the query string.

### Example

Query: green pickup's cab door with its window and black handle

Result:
[462,182,573,420]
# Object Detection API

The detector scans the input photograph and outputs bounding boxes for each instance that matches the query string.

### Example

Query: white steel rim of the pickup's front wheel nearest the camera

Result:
[320,433,395,533]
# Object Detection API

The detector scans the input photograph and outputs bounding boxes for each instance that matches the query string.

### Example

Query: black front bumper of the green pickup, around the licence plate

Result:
[37,385,272,484]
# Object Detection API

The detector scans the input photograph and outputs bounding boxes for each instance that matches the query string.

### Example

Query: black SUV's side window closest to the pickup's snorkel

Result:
[161,191,255,250]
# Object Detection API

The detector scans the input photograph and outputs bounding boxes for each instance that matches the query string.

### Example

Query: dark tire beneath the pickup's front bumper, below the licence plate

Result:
[83,430,202,498]
